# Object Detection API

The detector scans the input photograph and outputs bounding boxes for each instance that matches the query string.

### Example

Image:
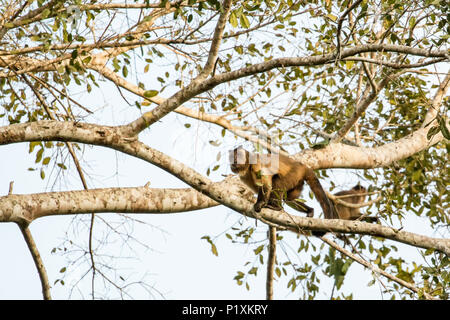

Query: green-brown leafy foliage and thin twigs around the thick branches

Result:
[0,0,450,299]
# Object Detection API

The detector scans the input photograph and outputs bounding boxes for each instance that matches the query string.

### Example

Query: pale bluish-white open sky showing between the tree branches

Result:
[0,5,442,300]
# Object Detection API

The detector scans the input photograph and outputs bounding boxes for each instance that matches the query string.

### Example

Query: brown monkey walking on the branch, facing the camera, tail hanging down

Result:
[229,147,338,220]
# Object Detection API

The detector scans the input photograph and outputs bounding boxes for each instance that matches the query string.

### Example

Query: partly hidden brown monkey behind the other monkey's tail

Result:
[334,183,378,222]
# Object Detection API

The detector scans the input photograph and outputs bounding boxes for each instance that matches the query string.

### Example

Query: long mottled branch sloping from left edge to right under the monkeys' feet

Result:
[0,121,450,254]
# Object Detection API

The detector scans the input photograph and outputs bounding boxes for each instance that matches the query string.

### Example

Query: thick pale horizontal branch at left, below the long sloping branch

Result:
[0,187,218,224]
